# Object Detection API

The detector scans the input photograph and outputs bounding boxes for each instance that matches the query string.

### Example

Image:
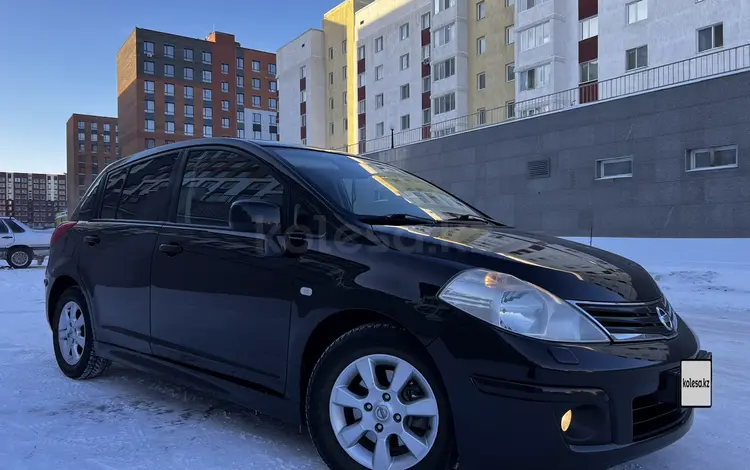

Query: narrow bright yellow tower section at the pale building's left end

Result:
[323,0,357,149]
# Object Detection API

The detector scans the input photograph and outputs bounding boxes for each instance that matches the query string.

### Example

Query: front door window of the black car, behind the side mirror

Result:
[177,150,284,227]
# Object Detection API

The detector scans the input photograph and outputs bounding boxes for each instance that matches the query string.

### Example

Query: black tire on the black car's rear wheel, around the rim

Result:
[52,287,111,380]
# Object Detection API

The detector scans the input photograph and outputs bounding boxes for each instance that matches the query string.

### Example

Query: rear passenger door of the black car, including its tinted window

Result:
[71,151,179,353]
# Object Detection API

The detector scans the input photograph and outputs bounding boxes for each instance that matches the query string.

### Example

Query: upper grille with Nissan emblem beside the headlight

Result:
[576,298,677,340]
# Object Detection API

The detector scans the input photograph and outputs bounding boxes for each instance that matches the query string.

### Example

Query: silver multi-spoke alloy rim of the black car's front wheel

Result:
[329,354,439,470]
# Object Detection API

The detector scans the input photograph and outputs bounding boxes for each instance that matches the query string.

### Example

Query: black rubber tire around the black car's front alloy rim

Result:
[305,323,457,470]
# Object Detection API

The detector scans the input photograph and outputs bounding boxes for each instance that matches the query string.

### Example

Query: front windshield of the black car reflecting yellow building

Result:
[274,147,483,221]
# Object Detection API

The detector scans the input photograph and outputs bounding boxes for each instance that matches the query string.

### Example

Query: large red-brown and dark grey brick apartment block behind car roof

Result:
[117,28,279,155]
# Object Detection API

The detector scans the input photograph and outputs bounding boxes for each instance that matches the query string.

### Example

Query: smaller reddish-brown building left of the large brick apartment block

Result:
[65,114,120,212]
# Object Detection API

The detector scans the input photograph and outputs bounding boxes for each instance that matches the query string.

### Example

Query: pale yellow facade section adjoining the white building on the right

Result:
[467,0,516,125]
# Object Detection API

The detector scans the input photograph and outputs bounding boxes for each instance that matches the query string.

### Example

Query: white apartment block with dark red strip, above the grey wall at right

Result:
[510,0,750,115]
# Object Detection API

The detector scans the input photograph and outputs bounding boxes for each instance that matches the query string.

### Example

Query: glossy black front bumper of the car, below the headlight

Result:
[429,316,710,470]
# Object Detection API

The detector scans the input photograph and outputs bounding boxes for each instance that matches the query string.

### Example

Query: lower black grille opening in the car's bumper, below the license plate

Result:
[633,393,689,442]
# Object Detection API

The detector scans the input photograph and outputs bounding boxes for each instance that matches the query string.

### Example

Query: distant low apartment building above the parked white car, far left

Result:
[0,172,68,228]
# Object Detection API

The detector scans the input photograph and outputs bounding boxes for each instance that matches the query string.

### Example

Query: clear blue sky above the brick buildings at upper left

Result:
[0,0,340,173]
